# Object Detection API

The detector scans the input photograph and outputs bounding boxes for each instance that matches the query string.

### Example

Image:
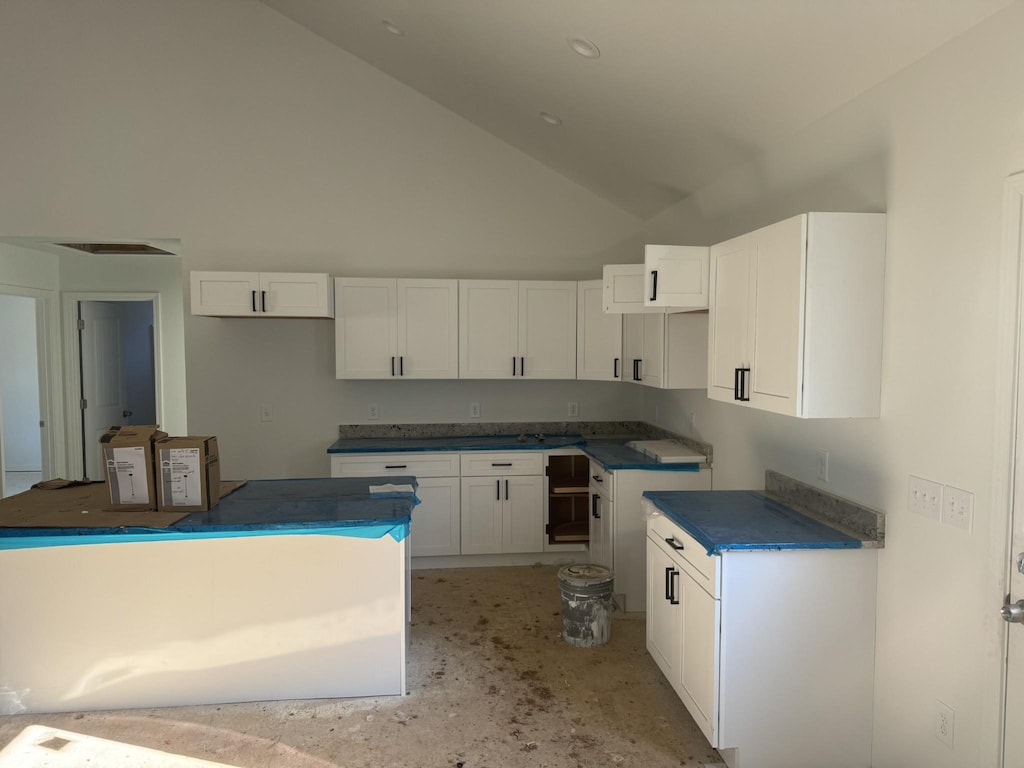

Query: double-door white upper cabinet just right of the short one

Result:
[335,278,459,379]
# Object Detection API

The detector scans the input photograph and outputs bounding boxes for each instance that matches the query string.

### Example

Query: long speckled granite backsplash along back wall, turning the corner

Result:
[338,421,713,464]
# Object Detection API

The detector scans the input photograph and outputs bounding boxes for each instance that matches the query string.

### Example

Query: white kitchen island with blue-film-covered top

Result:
[0,477,416,714]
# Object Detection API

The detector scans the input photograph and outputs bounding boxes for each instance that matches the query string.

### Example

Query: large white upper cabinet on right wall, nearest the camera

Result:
[708,213,886,418]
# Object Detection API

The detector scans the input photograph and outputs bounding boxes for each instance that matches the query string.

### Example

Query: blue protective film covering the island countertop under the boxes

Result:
[0,476,419,549]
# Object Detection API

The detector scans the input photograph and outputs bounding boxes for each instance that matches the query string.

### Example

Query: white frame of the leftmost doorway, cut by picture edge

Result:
[0,284,67,492]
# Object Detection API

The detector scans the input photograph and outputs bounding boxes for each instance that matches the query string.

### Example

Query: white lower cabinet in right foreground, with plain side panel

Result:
[644,512,878,768]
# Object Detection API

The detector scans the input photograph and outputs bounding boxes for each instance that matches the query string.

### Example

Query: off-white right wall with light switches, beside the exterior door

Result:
[646,3,1024,768]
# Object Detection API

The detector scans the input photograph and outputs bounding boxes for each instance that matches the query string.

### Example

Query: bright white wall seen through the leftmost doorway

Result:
[0,293,42,472]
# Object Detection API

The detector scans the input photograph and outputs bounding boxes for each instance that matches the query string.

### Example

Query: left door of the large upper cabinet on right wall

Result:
[708,234,753,402]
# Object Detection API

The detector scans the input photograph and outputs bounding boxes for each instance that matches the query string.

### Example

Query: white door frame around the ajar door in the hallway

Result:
[63,291,164,480]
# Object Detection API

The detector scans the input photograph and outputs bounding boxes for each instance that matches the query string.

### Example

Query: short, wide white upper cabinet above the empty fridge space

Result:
[189,271,334,317]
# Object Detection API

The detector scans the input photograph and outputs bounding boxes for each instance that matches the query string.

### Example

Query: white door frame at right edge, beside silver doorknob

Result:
[982,172,1024,768]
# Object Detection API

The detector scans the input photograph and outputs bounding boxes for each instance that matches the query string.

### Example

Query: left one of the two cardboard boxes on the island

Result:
[99,425,167,510]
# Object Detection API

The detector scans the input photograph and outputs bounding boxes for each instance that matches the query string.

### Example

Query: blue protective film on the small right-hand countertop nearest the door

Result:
[643,490,862,555]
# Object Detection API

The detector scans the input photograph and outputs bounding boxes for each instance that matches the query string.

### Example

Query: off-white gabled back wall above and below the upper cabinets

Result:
[0,0,641,477]
